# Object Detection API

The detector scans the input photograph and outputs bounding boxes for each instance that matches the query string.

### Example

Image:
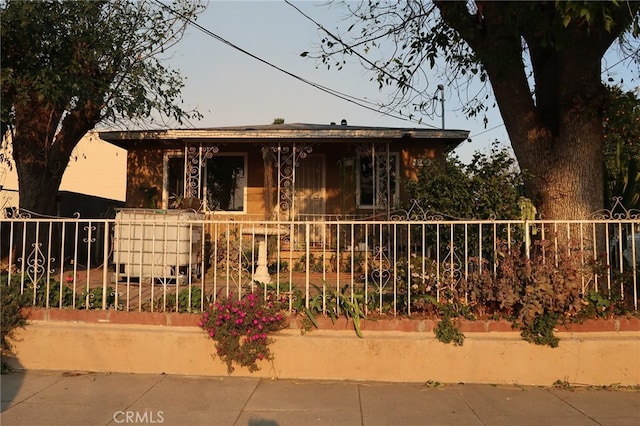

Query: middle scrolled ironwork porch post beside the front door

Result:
[271,143,313,219]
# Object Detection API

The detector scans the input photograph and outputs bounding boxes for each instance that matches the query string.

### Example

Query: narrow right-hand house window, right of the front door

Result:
[357,153,399,208]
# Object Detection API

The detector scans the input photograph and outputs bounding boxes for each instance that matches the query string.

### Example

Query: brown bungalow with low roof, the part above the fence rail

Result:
[100,120,469,221]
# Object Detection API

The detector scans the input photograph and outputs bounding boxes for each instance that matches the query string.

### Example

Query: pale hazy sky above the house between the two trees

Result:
[158,0,508,161]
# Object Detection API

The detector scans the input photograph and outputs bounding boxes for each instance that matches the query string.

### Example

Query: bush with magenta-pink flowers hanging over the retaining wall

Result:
[198,293,285,374]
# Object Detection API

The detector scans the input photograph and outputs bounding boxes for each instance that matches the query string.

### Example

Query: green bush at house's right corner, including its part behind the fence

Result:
[406,143,535,282]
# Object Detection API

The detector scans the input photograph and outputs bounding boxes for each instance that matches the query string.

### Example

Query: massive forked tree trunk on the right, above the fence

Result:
[436,1,616,219]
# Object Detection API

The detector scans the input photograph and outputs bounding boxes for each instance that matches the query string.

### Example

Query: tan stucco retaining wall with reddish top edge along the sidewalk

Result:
[6,310,640,385]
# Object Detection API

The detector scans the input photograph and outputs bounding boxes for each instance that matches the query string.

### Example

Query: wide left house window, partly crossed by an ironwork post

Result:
[164,153,247,212]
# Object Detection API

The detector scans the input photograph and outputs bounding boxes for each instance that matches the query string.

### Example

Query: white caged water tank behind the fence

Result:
[114,209,204,283]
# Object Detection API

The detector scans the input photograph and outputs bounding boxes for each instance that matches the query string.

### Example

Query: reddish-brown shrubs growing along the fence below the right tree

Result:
[390,240,637,347]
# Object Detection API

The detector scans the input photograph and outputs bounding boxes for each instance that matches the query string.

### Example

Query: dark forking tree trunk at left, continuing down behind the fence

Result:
[11,97,99,272]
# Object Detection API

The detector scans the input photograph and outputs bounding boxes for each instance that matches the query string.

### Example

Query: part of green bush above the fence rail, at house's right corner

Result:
[406,142,527,219]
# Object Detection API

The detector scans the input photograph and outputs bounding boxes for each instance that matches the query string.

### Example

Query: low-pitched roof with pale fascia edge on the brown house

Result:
[99,123,469,149]
